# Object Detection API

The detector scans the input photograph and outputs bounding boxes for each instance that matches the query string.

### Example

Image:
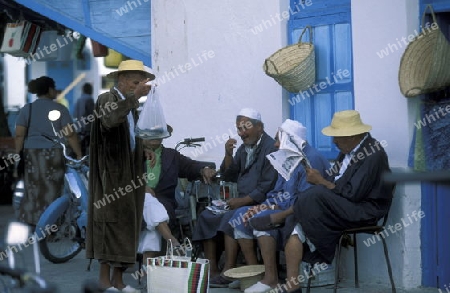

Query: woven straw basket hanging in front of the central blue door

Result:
[263,26,316,93]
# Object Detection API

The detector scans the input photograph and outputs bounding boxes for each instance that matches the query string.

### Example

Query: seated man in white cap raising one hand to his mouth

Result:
[193,108,277,287]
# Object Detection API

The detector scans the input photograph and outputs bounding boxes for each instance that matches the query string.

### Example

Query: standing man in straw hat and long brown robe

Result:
[86,60,155,293]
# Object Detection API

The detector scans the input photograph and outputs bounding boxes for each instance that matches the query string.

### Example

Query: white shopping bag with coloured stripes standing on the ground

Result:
[146,241,209,293]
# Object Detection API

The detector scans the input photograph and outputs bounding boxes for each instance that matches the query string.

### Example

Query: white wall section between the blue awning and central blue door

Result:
[152,0,288,164]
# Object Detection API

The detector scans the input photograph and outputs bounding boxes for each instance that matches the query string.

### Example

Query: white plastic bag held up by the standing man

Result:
[135,86,170,139]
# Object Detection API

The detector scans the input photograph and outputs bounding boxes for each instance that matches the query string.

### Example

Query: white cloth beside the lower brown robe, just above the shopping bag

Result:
[138,193,169,253]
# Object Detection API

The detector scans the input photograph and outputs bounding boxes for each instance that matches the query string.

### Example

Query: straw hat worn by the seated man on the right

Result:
[322,110,372,136]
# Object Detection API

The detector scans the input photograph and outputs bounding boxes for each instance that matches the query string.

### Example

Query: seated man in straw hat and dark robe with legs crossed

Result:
[249,110,393,292]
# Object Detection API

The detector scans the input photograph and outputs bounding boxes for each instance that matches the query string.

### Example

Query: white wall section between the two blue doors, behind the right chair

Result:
[344,0,421,288]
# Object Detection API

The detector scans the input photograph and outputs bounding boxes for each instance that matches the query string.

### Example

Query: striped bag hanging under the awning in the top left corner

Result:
[0,20,41,58]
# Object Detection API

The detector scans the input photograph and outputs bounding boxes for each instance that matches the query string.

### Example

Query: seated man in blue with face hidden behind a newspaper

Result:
[228,119,330,293]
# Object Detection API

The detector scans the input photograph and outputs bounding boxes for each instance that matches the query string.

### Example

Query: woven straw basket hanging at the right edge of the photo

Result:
[398,5,450,98]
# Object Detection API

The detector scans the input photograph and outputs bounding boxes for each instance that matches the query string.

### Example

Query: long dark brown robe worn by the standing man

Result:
[86,89,145,264]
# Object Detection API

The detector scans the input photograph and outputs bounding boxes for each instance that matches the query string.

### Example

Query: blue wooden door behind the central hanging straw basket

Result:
[288,0,354,159]
